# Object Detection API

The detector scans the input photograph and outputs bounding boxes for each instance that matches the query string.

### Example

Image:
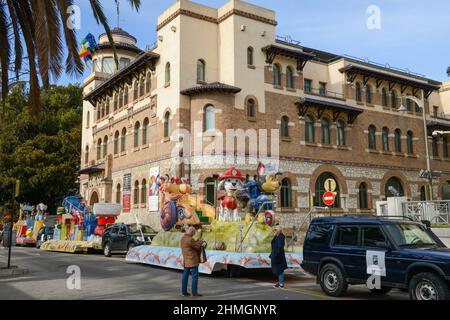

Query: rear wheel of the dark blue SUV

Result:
[320,263,348,297]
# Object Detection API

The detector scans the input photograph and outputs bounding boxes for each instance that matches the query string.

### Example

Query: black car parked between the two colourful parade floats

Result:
[102,224,156,257]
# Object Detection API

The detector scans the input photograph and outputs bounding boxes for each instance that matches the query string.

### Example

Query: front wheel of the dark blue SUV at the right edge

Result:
[409,272,450,300]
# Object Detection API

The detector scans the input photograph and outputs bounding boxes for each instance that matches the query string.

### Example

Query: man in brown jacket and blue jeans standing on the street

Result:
[180,227,205,297]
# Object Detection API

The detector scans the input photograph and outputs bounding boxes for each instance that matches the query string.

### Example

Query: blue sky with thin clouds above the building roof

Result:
[58,0,450,84]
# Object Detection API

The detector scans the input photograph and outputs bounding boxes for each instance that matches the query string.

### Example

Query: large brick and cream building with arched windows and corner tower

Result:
[80,0,450,228]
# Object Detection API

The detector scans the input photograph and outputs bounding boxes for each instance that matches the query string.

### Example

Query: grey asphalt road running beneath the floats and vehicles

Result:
[0,247,408,300]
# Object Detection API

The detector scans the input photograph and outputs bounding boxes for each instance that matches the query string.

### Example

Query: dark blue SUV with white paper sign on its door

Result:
[302,216,450,300]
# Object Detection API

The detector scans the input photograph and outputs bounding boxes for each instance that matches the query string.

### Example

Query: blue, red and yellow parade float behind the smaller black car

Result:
[41,196,121,253]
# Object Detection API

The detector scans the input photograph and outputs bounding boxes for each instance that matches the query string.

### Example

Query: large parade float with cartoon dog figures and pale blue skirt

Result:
[126,164,302,274]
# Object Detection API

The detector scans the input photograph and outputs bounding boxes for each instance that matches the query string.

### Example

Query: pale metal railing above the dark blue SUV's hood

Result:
[402,201,450,225]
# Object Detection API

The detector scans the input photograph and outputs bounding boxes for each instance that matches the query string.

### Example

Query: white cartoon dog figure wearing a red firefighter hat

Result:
[218,168,245,221]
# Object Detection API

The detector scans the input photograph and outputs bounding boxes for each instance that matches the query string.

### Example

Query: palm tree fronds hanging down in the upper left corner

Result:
[0,0,141,115]
